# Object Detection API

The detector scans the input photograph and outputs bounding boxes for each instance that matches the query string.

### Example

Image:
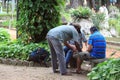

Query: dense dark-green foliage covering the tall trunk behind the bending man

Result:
[17,0,65,43]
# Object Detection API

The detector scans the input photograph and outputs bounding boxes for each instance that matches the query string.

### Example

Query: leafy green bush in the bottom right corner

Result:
[87,58,120,80]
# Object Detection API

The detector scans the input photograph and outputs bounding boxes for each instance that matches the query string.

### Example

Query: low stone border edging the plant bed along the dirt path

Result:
[0,57,51,67]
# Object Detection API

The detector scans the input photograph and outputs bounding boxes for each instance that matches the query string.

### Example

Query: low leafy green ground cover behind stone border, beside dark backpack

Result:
[0,41,49,60]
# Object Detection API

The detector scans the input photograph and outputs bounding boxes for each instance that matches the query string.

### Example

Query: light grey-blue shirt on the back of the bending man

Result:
[47,25,79,42]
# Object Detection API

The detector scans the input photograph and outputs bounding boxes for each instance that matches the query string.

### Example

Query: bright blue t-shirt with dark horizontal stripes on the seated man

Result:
[88,31,106,58]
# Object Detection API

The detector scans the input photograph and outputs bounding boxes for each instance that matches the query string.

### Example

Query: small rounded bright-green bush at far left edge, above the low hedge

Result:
[0,28,10,42]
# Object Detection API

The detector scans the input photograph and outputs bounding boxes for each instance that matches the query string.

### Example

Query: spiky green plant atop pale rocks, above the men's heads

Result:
[70,6,91,21]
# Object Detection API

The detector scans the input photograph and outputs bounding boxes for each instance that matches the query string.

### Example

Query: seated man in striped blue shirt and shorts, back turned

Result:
[74,27,106,73]
